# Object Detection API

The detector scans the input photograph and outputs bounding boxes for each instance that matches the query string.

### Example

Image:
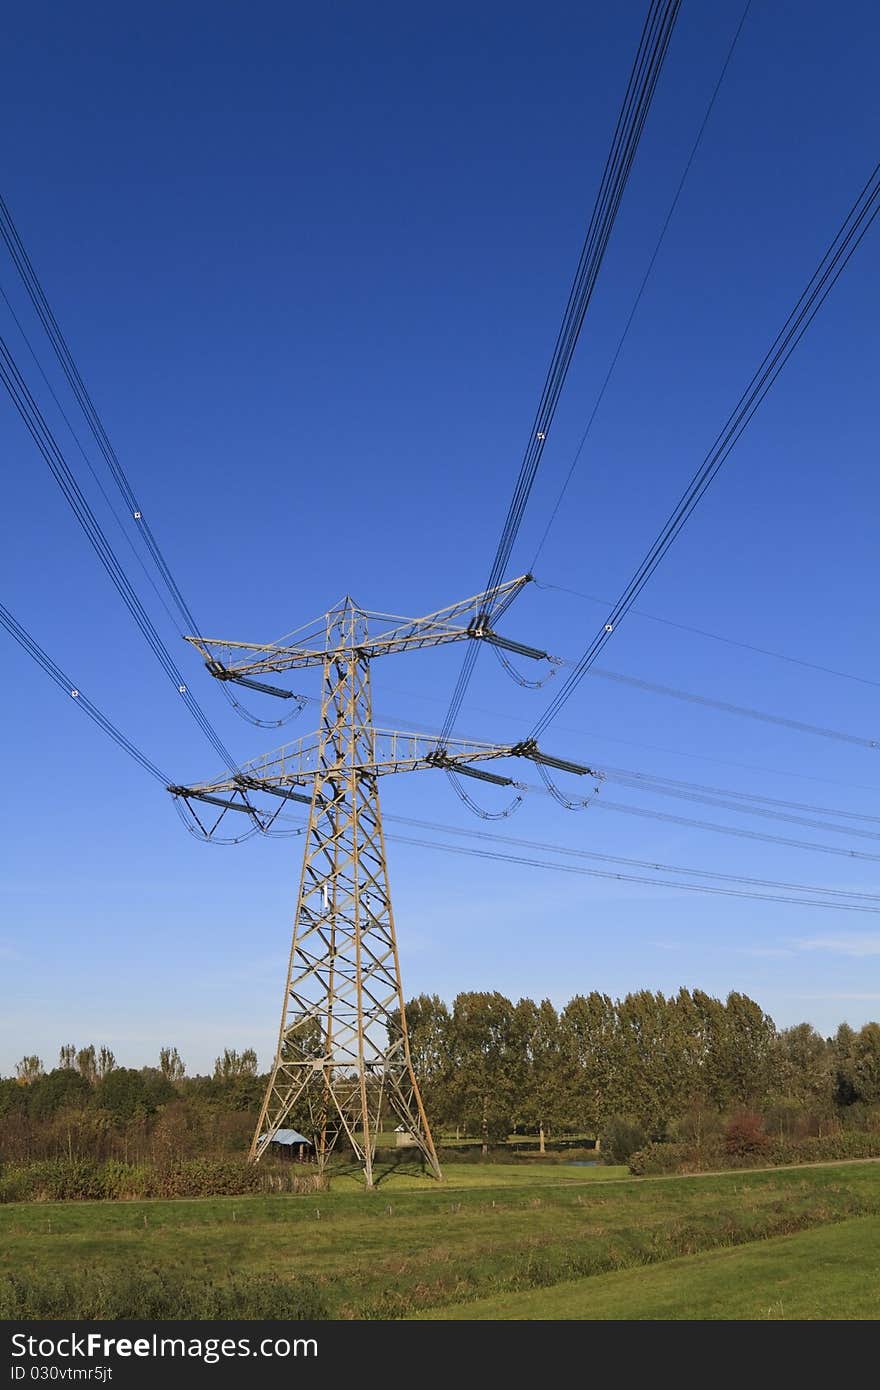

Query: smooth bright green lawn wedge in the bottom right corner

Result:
[421,1216,880,1322]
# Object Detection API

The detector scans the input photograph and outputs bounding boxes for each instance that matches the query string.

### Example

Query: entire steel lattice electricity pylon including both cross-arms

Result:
[168,575,589,1187]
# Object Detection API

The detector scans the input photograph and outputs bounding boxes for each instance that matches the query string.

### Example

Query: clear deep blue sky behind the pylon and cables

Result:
[0,0,880,1072]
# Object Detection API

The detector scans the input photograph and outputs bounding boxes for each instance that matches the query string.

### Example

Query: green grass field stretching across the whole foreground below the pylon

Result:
[0,1163,880,1318]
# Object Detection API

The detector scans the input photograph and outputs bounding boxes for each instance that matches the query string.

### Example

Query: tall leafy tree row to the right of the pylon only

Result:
[406,990,880,1144]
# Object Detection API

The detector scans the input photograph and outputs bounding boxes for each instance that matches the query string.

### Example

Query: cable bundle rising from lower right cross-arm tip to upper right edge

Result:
[530,164,880,738]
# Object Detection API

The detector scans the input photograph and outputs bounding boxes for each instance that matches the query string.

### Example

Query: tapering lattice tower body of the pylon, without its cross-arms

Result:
[250,602,439,1187]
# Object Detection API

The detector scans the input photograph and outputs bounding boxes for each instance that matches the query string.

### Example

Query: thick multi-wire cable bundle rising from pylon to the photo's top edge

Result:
[441,0,680,744]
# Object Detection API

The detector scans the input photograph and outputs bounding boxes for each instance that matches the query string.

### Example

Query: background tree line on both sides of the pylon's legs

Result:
[0,990,880,1158]
